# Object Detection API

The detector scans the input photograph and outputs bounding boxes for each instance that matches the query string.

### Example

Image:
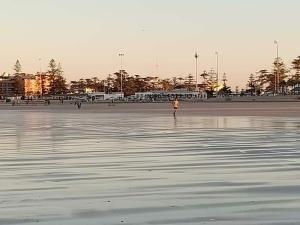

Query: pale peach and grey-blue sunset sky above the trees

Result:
[0,0,300,88]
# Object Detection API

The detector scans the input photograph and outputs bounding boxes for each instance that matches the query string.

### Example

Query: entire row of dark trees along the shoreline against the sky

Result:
[8,56,300,96]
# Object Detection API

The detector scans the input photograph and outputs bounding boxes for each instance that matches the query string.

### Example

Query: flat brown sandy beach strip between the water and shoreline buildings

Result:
[0,102,300,117]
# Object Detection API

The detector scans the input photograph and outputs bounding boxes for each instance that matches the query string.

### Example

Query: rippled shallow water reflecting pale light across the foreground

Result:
[0,111,300,225]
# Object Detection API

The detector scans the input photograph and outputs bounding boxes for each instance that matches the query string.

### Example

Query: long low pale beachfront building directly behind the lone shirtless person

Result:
[134,90,207,101]
